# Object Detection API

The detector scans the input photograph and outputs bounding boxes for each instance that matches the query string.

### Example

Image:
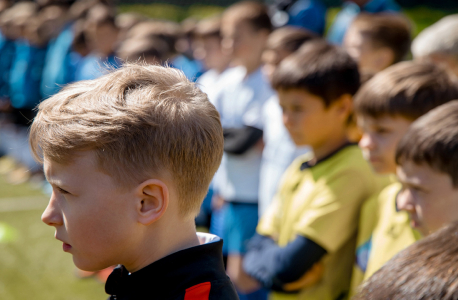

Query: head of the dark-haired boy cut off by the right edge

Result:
[396,101,458,236]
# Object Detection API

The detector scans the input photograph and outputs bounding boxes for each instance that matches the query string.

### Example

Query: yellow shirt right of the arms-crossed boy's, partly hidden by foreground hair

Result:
[364,182,421,279]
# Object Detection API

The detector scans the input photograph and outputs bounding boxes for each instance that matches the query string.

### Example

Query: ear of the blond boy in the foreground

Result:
[136,179,169,225]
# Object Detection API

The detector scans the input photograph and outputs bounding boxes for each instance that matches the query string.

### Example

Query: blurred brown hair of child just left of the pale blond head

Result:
[351,13,412,64]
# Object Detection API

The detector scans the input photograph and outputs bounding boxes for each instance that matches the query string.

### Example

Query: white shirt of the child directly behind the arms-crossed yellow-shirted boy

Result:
[259,95,311,216]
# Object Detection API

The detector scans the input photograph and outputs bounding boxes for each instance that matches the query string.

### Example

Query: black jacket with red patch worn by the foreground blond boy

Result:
[105,234,239,300]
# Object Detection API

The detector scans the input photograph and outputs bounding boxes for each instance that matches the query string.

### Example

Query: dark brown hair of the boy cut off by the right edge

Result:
[396,100,458,187]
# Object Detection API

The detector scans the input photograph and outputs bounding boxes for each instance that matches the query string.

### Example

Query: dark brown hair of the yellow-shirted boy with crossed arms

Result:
[272,40,360,107]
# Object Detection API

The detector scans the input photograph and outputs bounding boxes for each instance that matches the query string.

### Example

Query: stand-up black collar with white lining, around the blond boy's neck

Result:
[105,233,227,299]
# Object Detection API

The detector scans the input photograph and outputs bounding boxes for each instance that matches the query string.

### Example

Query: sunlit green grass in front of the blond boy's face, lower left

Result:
[0,177,107,300]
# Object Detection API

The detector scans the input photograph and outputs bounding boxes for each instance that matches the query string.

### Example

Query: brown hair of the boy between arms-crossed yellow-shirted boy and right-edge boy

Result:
[354,61,458,120]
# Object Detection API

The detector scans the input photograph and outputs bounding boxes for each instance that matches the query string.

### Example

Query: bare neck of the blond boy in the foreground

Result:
[124,220,200,273]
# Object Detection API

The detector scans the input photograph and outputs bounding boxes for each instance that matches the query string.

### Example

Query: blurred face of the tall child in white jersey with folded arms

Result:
[221,21,269,66]
